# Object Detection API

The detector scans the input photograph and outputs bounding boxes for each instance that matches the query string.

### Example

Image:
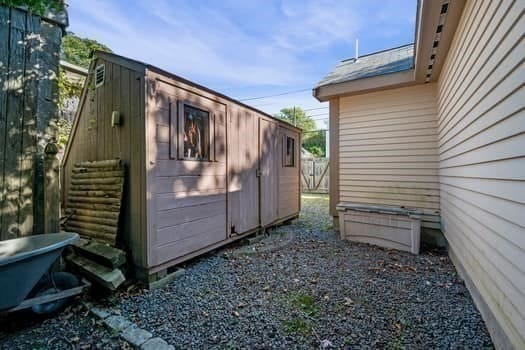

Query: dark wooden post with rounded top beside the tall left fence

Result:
[44,142,60,233]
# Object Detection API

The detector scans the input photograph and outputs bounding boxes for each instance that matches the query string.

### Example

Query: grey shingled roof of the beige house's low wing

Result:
[317,44,414,87]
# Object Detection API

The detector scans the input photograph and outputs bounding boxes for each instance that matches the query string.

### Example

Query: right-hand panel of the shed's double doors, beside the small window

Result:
[259,118,280,226]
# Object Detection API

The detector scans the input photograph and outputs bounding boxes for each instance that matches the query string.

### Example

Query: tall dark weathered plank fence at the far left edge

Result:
[0,6,62,240]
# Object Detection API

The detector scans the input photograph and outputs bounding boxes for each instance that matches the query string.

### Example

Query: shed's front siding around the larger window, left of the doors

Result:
[146,71,228,267]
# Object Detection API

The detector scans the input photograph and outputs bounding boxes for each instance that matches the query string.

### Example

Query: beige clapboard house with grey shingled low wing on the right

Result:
[314,0,525,349]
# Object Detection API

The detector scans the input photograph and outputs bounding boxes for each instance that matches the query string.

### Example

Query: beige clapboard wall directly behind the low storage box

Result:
[338,84,440,229]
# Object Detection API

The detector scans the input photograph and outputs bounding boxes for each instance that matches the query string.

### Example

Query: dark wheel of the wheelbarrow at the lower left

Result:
[31,272,80,315]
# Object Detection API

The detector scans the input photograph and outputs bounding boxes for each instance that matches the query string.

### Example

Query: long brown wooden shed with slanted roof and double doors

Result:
[62,52,301,277]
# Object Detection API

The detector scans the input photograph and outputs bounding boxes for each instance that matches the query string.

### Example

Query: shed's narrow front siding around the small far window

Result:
[278,125,301,218]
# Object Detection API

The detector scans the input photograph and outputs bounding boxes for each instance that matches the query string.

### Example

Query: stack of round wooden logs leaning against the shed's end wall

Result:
[64,159,124,245]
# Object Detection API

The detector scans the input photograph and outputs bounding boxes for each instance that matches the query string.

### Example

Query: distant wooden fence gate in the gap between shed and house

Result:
[301,158,330,193]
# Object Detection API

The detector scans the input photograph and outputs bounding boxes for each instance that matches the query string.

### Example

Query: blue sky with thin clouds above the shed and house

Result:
[68,0,416,127]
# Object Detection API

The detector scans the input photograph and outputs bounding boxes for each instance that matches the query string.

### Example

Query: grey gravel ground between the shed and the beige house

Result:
[0,195,493,349]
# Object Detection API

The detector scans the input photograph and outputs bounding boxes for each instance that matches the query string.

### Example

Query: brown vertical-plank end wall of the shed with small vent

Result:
[62,58,146,266]
